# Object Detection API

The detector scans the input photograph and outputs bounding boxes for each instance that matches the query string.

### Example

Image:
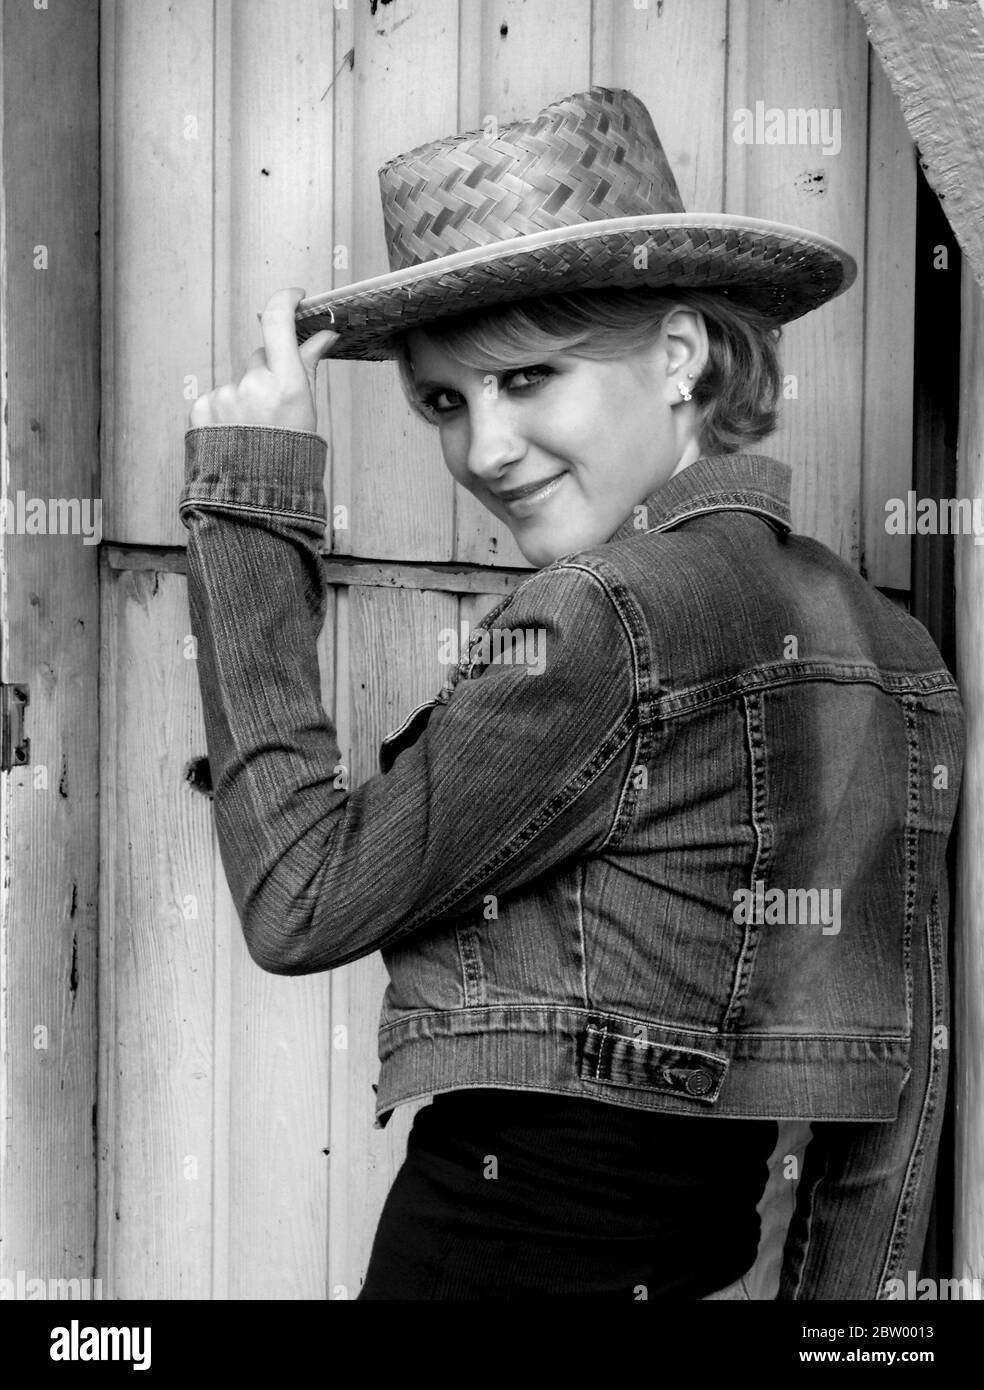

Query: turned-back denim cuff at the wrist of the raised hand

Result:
[178,425,328,521]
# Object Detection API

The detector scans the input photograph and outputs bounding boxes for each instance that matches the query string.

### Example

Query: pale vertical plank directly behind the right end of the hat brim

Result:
[725,0,867,566]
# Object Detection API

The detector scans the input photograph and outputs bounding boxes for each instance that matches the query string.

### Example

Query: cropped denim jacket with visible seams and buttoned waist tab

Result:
[179,425,963,1123]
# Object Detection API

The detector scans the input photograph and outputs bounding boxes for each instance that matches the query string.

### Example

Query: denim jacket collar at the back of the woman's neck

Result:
[609,453,792,541]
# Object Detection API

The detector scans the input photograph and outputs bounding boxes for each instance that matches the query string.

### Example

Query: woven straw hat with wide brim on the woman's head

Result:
[296,88,858,361]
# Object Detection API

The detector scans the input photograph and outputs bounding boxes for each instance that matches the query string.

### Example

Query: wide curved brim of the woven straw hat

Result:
[295,213,858,361]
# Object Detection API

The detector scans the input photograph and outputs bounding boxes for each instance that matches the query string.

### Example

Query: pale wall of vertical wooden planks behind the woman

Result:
[97,0,915,1298]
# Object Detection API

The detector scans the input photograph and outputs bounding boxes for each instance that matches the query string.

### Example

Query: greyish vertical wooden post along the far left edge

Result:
[0,0,101,1278]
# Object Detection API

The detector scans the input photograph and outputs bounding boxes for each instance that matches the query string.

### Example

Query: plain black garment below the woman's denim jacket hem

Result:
[359,1088,777,1300]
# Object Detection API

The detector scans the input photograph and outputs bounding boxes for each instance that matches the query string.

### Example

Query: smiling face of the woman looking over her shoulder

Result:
[409,313,706,567]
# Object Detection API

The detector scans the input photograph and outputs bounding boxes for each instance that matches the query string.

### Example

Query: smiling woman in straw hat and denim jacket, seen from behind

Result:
[181,89,962,1298]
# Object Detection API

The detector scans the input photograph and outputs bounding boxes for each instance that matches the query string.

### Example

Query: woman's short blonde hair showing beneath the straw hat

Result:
[393,285,782,453]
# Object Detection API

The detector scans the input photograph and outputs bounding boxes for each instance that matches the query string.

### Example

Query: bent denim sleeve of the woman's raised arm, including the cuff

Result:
[179,425,637,974]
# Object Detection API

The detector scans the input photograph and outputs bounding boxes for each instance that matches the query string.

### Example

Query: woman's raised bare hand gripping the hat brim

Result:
[188,288,338,431]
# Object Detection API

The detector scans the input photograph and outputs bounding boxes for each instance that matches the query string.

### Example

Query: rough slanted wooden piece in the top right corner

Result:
[855,0,984,296]
